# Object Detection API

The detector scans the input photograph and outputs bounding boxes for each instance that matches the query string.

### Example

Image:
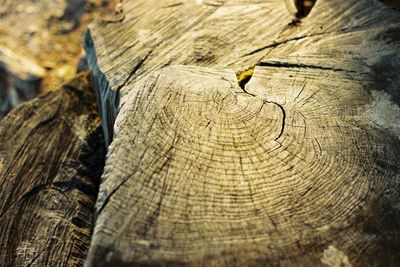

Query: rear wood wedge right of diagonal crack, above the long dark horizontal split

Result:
[255,0,400,104]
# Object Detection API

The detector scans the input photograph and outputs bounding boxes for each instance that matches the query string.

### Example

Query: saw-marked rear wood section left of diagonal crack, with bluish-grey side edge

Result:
[85,0,293,147]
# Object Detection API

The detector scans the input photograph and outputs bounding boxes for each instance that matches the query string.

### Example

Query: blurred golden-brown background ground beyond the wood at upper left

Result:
[0,0,116,118]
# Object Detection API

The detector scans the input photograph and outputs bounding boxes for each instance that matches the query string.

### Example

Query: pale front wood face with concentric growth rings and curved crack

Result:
[88,67,400,266]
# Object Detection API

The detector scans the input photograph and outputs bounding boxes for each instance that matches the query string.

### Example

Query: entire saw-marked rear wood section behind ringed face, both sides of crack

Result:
[85,0,400,146]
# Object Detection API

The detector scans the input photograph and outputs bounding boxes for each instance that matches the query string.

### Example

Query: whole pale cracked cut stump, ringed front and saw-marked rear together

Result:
[85,0,400,266]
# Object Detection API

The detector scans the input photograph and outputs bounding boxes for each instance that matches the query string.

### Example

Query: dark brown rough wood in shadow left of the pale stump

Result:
[0,74,104,266]
